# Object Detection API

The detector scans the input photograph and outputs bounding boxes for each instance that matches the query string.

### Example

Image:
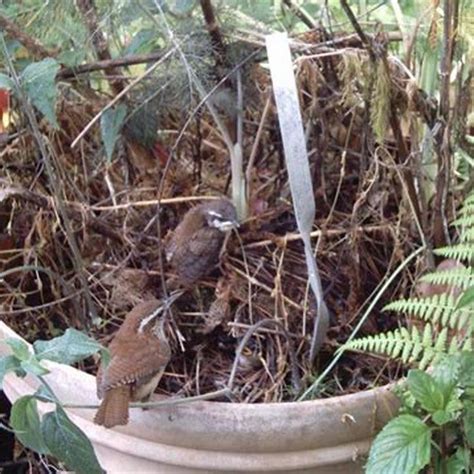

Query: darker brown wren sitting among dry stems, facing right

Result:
[166,199,239,285]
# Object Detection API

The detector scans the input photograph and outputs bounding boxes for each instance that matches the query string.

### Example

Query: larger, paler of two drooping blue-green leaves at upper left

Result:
[21,58,60,128]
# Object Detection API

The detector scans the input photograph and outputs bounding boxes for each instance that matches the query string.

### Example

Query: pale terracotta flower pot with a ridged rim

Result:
[0,323,398,474]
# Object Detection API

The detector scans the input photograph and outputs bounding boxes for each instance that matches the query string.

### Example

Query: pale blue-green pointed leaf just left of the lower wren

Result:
[33,328,104,365]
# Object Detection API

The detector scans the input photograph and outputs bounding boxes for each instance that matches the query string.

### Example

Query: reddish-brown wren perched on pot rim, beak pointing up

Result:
[94,292,182,428]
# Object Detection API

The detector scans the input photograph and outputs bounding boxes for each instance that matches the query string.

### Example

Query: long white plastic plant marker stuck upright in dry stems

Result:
[265,33,329,360]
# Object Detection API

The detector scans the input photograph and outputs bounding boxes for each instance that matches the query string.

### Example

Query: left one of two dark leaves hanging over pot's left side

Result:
[10,395,48,454]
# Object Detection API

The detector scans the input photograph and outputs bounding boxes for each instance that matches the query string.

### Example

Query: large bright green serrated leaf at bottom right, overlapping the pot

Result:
[366,415,431,474]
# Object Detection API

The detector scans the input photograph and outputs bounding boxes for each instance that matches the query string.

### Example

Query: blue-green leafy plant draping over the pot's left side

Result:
[0,329,108,474]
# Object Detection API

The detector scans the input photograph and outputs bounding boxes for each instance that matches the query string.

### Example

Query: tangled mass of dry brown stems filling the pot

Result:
[0,32,426,402]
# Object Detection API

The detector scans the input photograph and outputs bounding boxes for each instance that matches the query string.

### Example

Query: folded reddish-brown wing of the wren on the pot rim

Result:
[100,337,171,392]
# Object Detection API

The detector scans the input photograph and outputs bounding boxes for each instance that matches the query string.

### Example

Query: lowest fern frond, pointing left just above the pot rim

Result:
[342,324,448,369]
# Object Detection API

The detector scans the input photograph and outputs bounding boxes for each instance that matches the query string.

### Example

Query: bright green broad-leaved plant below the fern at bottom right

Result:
[367,352,474,474]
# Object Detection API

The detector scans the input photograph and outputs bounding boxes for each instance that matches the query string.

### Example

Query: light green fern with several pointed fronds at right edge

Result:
[341,194,474,369]
